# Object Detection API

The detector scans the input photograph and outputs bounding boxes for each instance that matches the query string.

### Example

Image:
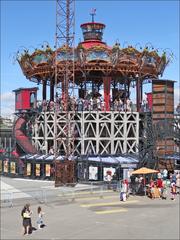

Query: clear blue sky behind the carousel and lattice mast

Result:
[1,0,180,115]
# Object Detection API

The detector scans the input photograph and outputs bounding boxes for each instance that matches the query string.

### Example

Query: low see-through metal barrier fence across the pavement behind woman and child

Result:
[0,181,121,208]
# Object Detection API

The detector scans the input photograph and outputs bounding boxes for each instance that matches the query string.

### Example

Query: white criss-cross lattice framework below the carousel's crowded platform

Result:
[32,111,140,156]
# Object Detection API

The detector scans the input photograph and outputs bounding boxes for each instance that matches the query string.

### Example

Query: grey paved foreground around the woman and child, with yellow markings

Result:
[1,175,180,239]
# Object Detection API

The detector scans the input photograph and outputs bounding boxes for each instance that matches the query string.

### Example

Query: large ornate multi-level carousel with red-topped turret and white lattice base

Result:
[14,4,169,158]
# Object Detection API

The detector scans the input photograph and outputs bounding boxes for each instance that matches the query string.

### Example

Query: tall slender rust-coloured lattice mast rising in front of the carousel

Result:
[53,0,74,158]
